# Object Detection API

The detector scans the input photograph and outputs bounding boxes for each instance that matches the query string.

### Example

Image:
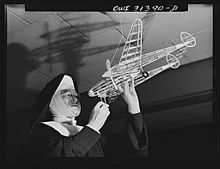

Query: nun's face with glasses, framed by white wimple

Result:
[60,89,81,115]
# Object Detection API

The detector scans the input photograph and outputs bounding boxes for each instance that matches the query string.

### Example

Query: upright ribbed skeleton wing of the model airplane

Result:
[119,19,143,72]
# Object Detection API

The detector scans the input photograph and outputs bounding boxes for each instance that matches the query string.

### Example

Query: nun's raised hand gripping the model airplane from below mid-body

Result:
[119,78,140,114]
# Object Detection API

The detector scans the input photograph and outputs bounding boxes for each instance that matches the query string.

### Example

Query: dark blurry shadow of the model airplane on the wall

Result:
[31,18,124,80]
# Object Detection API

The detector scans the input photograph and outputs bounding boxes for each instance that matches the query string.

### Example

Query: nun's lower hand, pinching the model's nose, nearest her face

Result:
[88,101,110,131]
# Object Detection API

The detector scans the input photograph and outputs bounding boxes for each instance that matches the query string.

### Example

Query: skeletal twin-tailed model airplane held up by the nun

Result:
[88,19,196,103]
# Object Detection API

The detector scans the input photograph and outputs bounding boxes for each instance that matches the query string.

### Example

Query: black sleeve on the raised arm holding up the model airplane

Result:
[126,113,149,156]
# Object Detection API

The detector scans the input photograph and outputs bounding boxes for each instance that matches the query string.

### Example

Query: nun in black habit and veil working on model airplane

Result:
[25,74,149,158]
